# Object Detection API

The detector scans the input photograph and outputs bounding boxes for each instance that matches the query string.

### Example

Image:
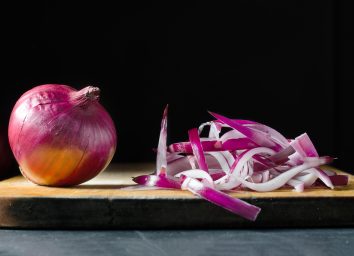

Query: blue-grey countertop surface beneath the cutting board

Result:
[0,228,354,256]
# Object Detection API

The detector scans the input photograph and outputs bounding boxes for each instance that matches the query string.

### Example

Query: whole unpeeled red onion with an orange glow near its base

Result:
[8,84,117,186]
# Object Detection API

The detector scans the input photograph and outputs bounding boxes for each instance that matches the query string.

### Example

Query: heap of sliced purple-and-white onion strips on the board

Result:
[133,106,348,221]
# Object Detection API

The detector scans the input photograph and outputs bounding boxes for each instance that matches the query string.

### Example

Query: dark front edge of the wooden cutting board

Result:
[0,195,354,229]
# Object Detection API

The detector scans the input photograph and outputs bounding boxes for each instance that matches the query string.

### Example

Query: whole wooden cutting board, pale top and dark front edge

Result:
[0,164,354,229]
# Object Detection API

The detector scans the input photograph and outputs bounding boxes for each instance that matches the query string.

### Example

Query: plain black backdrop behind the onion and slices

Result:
[0,0,354,169]
